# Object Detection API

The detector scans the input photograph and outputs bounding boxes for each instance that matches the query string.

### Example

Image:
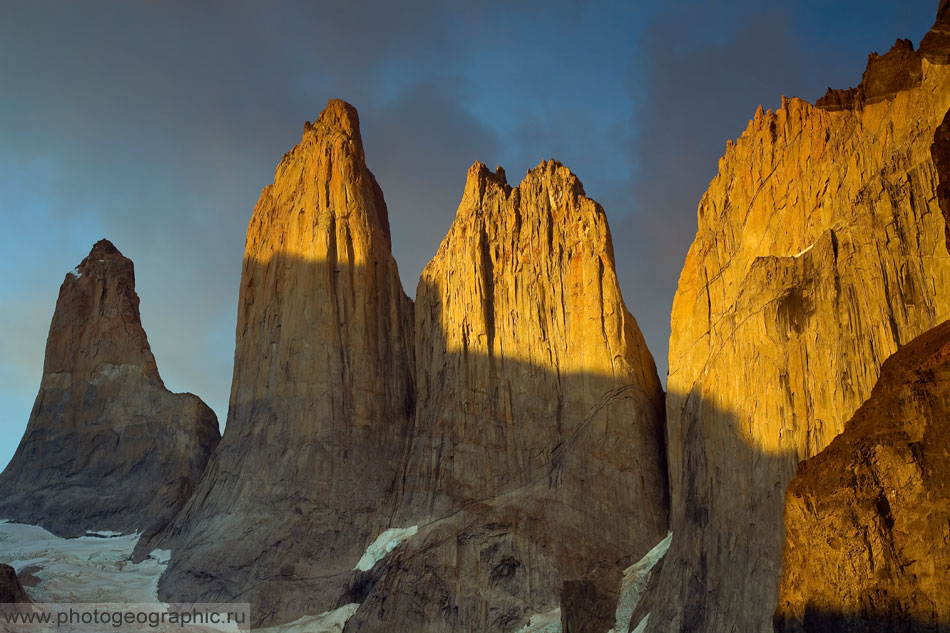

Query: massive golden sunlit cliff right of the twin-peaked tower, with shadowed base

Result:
[648,3,950,632]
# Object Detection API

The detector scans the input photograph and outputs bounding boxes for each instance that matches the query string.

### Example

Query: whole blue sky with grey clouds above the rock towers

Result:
[0,0,937,465]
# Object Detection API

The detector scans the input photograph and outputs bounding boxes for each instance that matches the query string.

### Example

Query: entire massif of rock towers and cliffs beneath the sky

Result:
[0,0,950,633]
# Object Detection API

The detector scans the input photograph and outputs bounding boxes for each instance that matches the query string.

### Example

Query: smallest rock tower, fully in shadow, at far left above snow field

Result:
[0,240,219,536]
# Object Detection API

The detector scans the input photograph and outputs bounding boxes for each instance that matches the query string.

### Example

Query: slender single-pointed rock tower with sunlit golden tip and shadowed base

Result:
[155,101,413,624]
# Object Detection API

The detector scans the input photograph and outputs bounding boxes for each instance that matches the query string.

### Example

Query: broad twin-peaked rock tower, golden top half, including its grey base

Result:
[347,161,667,631]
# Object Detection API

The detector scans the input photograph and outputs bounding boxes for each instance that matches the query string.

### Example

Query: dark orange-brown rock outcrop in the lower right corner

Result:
[775,321,950,633]
